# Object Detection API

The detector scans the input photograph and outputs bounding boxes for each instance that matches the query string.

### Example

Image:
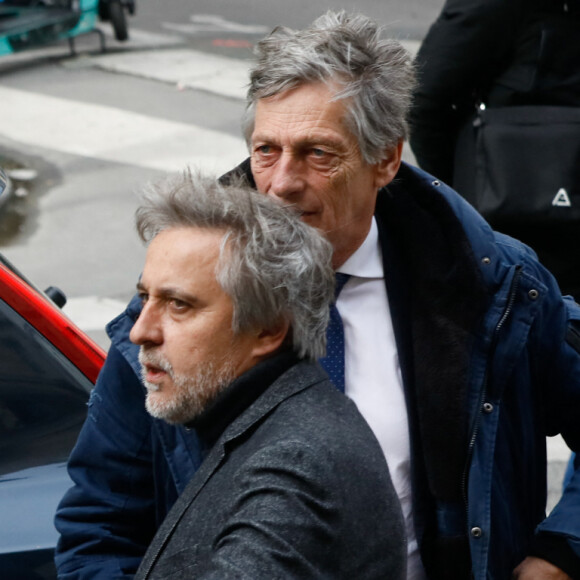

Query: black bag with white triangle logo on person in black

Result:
[453,106,580,227]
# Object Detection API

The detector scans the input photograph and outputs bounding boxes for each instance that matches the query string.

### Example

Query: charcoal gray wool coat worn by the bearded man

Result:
[136,362,406,580]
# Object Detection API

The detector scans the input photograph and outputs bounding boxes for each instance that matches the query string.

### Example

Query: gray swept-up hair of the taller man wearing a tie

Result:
[243,11,415,163]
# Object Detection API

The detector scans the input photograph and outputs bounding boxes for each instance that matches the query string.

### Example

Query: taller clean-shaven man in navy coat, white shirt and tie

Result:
[57,12,580,580]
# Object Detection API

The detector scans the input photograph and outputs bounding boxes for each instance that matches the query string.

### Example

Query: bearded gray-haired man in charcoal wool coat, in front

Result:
[131,174,406,580]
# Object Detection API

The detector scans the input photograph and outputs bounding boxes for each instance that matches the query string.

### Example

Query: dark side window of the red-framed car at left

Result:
[0,300,92,475]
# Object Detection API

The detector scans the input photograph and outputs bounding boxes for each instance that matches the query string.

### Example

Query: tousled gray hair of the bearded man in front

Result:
[136,171,334,360]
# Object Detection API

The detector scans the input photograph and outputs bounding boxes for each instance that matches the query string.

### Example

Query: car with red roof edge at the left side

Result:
[0,171,105,580]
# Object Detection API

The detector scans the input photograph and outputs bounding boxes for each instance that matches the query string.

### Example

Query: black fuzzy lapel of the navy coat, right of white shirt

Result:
[377,166,489,502]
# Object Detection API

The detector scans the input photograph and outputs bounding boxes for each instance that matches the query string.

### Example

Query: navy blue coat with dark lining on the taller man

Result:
[56,165,580,580]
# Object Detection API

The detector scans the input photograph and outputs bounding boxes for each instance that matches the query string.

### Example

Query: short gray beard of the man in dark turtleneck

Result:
[139,347,235,425]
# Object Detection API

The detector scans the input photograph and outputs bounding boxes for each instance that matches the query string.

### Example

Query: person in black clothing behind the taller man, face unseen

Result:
[410,0,580,301]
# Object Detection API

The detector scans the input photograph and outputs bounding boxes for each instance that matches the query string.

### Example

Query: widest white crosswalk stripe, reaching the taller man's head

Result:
[0,86,247,173]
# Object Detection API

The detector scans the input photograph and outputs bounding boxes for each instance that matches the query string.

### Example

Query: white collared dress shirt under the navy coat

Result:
[336,218,425,580]
